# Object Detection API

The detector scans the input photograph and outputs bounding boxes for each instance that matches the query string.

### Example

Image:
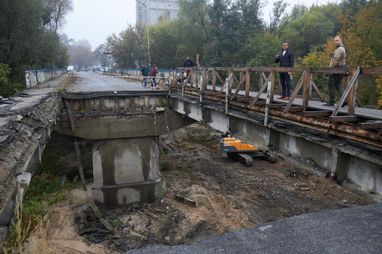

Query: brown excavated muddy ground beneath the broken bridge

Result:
[22,124,372,253]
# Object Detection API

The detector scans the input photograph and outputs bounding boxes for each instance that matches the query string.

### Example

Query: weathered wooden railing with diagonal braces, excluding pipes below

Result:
[172,67,382,121]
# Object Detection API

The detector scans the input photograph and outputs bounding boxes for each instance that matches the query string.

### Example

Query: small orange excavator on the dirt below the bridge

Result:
[220,133,277,167]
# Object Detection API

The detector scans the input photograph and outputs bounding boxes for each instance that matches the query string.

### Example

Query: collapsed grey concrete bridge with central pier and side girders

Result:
[0,66,382,247]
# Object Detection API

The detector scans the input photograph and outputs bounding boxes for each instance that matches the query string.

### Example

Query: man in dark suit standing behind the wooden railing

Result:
[275,41,294,100]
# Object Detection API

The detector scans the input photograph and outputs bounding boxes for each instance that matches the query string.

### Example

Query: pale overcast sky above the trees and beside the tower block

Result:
[62,0,339,49]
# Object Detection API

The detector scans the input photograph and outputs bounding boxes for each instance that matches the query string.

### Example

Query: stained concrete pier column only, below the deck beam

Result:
[92,137,163,207]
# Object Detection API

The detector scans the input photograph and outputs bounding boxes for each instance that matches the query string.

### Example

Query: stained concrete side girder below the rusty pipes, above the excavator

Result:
[169,97,382,195]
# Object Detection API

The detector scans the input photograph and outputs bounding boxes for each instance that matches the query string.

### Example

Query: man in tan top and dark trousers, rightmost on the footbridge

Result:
[324,35,346,106]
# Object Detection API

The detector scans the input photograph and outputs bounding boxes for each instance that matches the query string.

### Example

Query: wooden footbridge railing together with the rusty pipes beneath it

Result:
[170,67,382,147]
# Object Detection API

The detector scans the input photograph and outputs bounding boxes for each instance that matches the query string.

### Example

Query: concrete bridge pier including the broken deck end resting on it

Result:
[55,91,194,207]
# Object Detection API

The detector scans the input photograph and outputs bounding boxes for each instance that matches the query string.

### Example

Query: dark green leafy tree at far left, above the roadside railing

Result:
[0,0,71,95]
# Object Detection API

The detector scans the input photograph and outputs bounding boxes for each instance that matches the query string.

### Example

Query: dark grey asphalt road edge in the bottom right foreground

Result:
[126,203,382,254]
